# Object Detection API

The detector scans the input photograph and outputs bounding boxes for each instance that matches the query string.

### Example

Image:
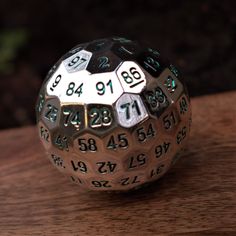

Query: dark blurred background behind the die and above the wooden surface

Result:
[0,0,236,129]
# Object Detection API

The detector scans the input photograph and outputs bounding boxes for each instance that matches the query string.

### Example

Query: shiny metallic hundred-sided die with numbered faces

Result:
[36,37,191,190]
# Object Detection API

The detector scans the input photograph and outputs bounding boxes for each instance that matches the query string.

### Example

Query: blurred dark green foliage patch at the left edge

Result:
[0,29,28,73]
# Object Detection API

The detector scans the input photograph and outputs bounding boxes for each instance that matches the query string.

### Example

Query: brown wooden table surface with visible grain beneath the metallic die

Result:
[0,92,236,236]
